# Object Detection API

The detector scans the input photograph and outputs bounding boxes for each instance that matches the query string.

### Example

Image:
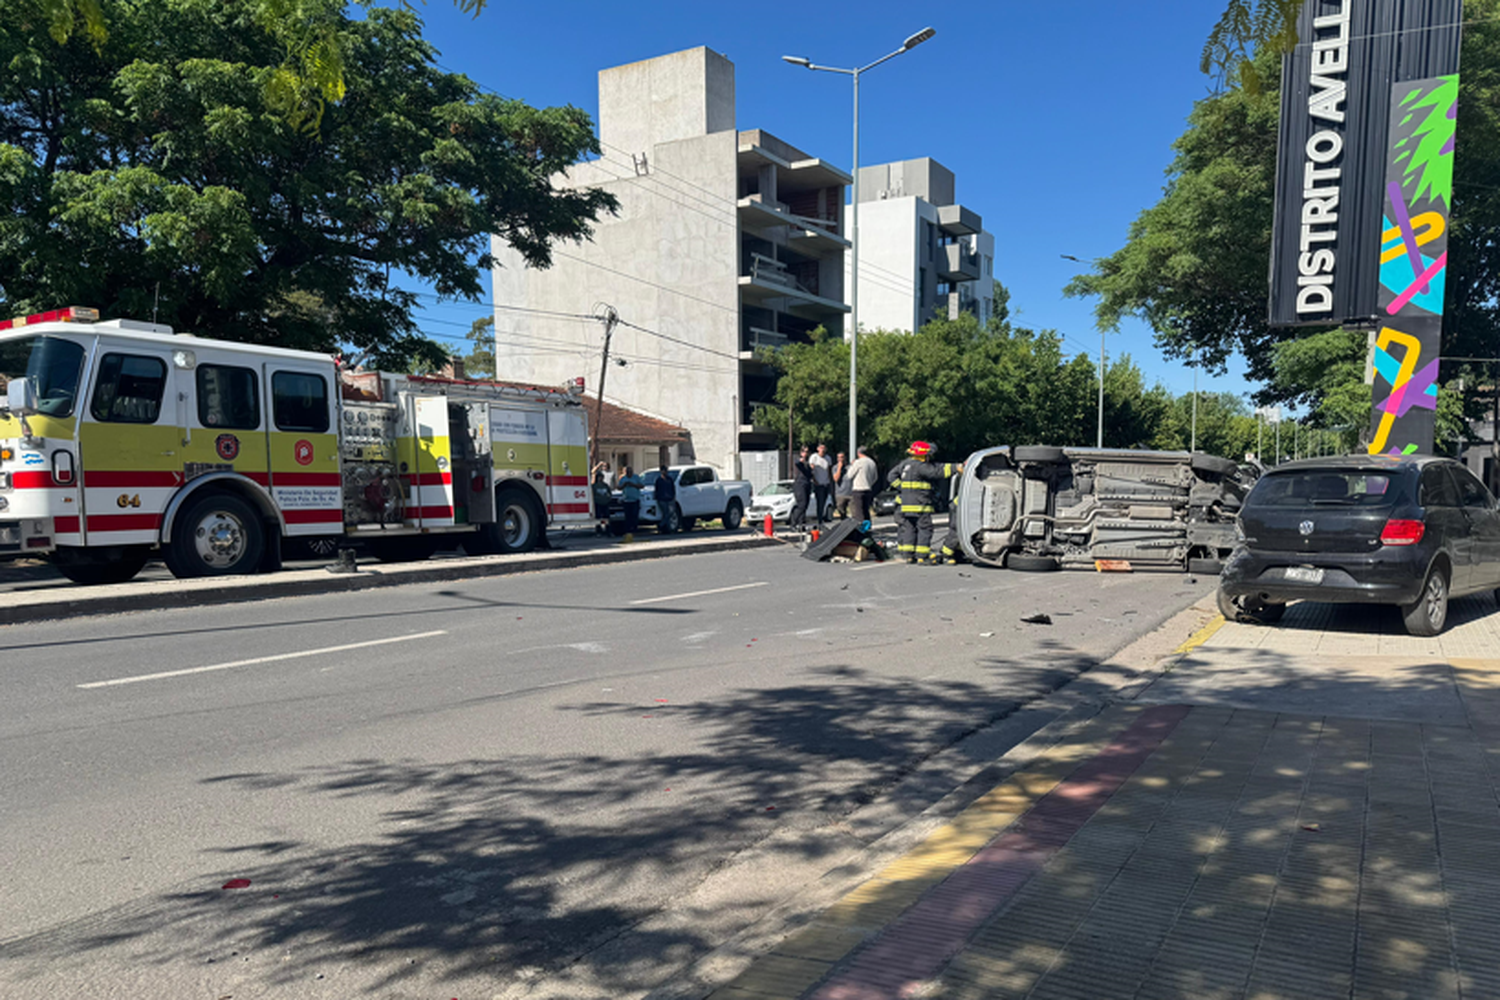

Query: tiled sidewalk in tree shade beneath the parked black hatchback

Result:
[713,603,1500,1000]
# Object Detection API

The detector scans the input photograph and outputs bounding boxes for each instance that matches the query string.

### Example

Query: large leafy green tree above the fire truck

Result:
[0,0,615,367]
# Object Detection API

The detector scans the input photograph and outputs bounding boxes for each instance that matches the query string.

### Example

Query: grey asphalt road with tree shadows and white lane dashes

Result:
[0,549,1211,1000]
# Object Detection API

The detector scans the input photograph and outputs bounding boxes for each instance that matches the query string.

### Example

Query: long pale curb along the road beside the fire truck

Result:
[0,534,779,625]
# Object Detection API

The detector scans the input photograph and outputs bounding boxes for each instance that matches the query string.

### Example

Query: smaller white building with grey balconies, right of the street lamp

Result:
[845,157,995,331]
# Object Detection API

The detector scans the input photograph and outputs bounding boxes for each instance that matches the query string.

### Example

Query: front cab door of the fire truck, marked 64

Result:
[78,345,188,546]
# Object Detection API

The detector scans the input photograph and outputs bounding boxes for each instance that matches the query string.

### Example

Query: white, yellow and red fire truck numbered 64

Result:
[0,307,593,583]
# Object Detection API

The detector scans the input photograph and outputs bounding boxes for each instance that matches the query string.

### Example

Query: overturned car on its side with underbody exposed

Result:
[953,445,1257,573]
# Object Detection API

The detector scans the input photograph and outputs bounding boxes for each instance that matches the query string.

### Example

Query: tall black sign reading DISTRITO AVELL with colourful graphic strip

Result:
[1269,0,1463,454]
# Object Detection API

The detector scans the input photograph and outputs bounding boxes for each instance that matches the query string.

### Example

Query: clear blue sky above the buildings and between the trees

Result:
[405,0,1253,407]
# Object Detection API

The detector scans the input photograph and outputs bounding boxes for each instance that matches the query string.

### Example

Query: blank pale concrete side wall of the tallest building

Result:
[494,130,740,474]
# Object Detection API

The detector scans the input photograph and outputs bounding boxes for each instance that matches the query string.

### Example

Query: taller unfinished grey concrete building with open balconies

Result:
[494,48,852,474]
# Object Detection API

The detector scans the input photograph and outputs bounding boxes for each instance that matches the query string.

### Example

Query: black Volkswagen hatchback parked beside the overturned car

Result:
[1218,456,1500,636]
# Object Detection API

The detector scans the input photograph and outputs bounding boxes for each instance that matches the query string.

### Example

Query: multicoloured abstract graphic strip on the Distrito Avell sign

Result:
[1370,73,1458,454]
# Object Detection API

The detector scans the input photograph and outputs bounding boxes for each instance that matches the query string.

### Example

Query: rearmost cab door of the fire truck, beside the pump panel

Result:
[264,361,344,535]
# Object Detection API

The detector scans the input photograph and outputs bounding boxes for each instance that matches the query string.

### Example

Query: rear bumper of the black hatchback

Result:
[1220,546,1436,604]
